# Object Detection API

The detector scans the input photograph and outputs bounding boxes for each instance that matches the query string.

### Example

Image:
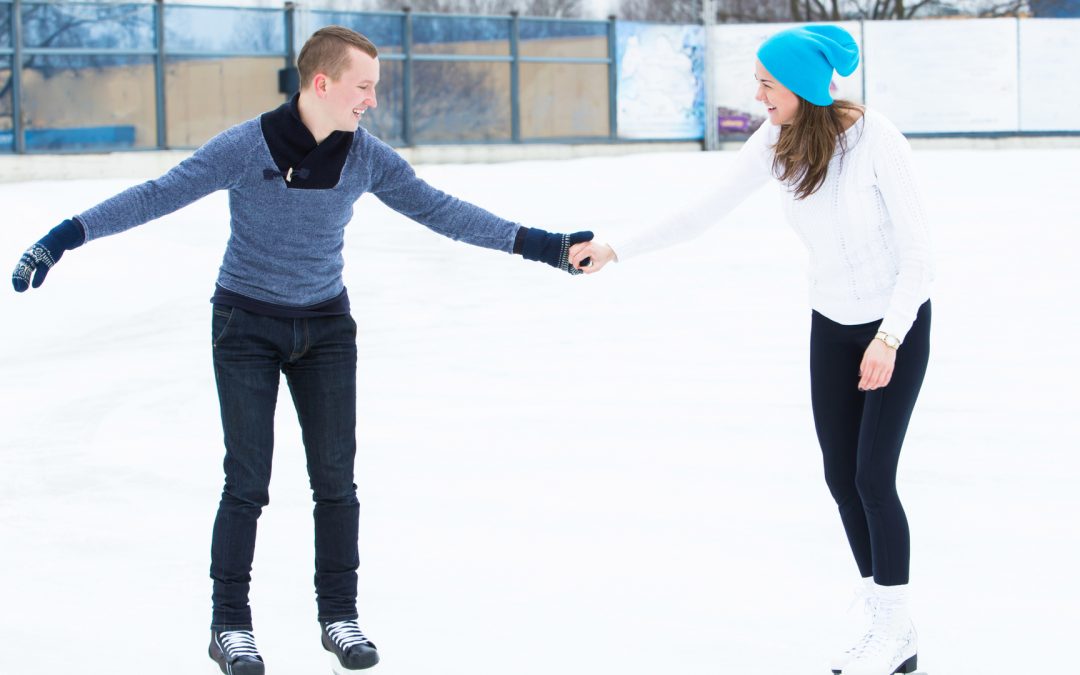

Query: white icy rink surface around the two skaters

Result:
[0,150,1080,675]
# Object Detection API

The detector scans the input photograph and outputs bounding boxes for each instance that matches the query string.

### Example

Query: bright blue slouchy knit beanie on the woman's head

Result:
[757,26,859,106]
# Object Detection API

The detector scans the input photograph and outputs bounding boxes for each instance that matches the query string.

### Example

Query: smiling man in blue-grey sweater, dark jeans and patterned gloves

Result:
[12,26,592,675]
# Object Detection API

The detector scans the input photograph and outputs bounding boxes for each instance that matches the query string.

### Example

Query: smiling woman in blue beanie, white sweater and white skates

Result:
[570,26,932,675]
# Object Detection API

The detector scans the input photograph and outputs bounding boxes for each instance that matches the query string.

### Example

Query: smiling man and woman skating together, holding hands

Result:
[12,26,932,675]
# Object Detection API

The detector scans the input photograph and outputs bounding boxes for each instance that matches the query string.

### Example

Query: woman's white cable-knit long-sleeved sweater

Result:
[609,109,933,340]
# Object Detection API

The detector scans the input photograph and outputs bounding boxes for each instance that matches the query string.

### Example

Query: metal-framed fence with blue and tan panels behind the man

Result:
[0,0,618,153]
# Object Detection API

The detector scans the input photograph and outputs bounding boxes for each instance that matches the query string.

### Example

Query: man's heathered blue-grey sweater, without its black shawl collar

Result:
[77,119,521,307]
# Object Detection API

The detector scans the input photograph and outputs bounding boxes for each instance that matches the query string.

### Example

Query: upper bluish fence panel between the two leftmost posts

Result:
[22,3,154,50]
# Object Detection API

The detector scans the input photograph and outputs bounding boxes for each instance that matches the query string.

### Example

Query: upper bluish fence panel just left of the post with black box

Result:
[165,5,286,56]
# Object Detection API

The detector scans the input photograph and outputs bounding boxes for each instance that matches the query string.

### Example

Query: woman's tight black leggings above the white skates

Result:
[810,300,930,585]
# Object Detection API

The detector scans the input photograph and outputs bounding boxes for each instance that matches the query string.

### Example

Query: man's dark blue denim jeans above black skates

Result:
[211,305,360,631]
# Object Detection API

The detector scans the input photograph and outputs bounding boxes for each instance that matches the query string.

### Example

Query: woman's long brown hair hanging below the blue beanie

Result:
[772,97,862,199]
